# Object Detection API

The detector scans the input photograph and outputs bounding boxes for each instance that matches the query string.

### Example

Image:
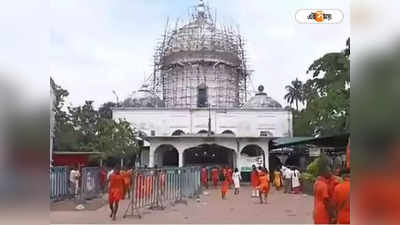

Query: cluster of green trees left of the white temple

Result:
[50,79,139,161]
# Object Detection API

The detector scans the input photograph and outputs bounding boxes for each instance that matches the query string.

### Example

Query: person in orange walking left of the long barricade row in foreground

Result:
[108,167,125,220]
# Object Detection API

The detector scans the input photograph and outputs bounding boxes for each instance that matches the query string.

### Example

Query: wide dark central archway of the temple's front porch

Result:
[183,144,236,168]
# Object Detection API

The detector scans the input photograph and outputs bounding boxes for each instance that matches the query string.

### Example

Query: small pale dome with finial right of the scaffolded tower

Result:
[243,85,282,109]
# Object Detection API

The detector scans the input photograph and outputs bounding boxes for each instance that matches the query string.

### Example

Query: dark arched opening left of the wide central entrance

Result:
[154,145,179,167]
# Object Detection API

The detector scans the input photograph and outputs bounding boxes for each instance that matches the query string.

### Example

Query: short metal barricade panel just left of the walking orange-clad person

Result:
[80,167,101,200]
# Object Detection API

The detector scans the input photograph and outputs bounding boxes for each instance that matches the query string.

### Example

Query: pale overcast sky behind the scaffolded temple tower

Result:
[50,0,350,109]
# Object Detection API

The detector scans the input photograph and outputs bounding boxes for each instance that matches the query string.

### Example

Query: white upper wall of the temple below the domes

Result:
[113,108,293,137]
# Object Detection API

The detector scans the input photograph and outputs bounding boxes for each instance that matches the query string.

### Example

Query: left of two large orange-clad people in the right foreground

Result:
[313,169,332,224]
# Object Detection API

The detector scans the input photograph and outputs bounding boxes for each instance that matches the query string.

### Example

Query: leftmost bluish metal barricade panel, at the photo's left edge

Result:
[50,166,70,201]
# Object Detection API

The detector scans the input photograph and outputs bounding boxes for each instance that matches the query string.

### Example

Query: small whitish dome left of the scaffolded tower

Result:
[122,84,164,107]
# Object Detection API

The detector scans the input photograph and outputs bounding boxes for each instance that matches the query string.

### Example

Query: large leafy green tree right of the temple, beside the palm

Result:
[294,39,350,136]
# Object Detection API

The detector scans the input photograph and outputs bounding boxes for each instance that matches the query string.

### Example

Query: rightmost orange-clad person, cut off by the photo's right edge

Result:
[333,169,350,224]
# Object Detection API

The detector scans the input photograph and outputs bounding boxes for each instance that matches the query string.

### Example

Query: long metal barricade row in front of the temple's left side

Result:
[123,167,201,218]
